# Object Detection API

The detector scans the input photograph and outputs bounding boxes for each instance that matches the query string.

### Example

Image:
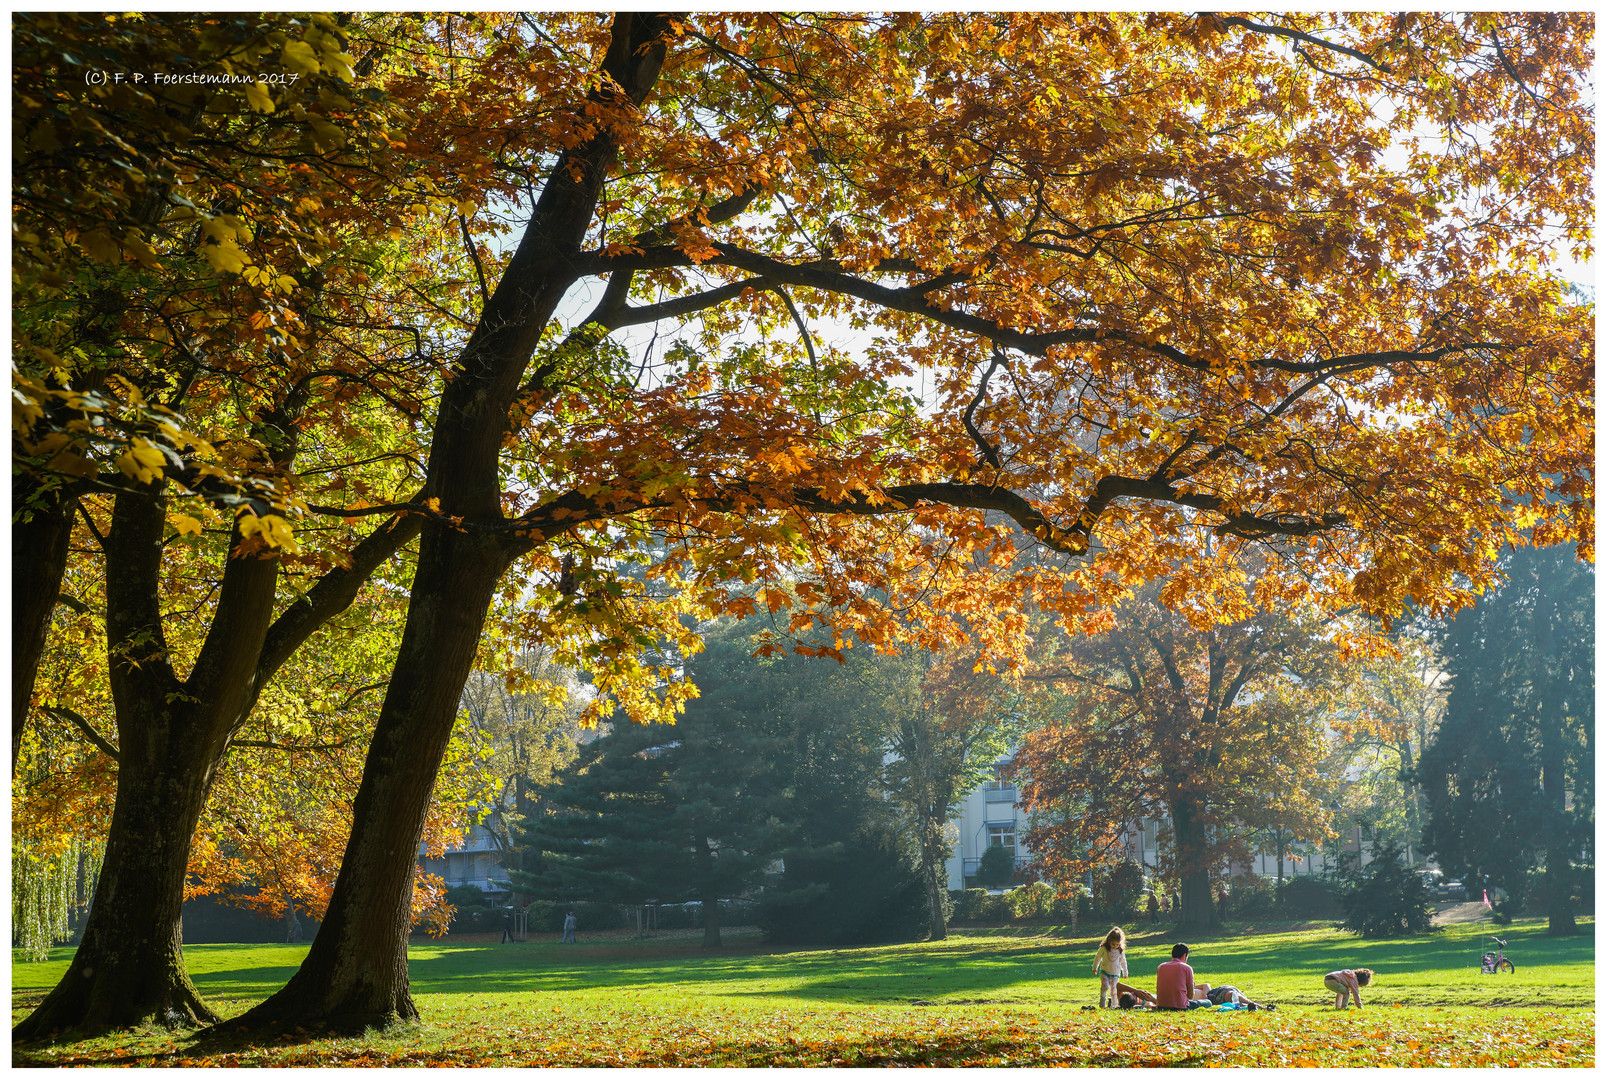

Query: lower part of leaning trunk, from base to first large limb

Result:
[222,527,508,1030]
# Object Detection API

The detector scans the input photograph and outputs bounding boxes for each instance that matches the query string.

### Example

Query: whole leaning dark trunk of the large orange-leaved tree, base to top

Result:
[208,13,670,1030]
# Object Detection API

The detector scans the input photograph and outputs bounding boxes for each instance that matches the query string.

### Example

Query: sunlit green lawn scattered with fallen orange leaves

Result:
[11,921,1596,1066]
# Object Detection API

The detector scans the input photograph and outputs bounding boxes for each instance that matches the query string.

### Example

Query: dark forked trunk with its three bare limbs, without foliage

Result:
[13,490,418,1040]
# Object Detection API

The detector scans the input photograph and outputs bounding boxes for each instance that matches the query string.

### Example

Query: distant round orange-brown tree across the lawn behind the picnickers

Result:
[1011,587,1335,929]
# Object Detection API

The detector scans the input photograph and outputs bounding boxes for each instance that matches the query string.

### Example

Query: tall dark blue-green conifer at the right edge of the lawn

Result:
[1417,548,1596,934]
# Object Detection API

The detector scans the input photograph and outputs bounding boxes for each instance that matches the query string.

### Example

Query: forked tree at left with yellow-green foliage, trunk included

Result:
[13,13,488,1038]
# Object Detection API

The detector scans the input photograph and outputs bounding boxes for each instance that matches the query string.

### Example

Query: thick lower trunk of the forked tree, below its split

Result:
[11,703,217,1043]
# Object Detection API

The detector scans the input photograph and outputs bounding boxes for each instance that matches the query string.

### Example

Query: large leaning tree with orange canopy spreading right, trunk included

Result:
[18,13,1594,1027]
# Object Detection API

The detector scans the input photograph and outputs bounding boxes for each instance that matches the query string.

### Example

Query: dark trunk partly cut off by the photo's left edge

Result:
[11,476,72,776]
